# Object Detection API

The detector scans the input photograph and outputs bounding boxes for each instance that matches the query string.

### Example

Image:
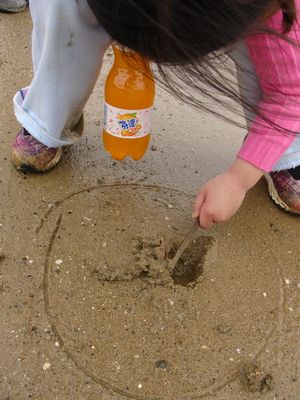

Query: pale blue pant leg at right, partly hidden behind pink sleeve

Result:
[230,42,300,171]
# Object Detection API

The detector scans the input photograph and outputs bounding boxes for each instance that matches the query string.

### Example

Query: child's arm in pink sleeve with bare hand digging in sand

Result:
[193,7,300,228]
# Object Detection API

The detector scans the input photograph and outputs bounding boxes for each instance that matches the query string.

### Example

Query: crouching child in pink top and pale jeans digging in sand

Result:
[12,0,300,228]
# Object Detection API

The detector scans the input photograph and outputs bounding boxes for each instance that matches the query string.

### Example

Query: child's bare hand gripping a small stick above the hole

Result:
[193,159,263,228]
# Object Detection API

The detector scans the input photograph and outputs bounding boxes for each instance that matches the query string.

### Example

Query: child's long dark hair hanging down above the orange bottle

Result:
[87,0,296,131]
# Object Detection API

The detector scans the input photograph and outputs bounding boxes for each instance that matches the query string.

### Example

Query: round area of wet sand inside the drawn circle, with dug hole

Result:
[39,186,278,399]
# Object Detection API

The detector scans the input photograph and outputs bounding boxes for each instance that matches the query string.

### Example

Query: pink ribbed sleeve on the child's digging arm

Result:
[238,0,300,171]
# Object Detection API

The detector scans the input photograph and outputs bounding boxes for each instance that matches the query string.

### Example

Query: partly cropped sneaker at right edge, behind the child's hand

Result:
[265,170,300,214]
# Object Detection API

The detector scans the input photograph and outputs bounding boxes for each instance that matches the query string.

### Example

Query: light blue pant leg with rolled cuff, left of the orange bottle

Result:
[14,0,109,147]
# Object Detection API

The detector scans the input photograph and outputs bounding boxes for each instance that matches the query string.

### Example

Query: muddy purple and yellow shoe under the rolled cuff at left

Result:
[12,128,62,172]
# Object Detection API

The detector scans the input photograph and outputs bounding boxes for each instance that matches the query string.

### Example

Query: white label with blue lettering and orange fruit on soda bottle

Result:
[104,103,152,139]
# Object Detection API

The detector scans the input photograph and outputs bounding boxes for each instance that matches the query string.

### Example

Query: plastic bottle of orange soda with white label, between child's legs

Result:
[103,44,155,160]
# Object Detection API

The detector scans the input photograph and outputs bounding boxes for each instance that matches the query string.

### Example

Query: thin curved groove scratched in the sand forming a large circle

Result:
[36,184,286,400]
